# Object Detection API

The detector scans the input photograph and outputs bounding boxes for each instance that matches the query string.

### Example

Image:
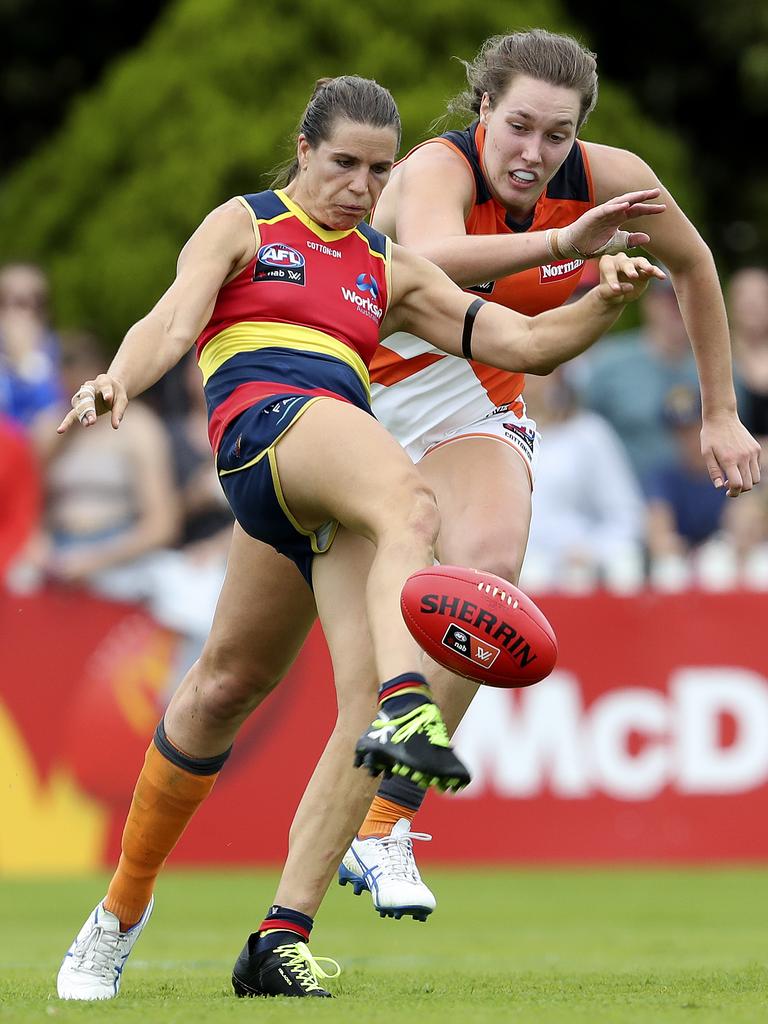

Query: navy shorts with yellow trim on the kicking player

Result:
[216,394,339,587]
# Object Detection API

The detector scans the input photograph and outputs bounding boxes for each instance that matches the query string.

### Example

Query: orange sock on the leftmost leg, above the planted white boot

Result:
[104,740,218,931]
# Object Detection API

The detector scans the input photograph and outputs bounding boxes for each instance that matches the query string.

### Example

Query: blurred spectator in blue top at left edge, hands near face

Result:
[0,263,66,457]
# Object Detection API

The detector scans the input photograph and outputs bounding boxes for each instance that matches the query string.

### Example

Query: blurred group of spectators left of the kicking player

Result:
[0,258,232,656]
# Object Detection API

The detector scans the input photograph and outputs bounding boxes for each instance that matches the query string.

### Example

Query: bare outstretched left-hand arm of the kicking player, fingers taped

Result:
[58,200,256,433]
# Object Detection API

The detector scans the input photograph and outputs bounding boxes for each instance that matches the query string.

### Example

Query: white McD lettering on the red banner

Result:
[457,667,768,800]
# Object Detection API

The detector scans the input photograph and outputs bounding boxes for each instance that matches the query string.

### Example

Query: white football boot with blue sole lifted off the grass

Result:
[339,818,436,921]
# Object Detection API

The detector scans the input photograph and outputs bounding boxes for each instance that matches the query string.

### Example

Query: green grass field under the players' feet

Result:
[0,869,768,1024]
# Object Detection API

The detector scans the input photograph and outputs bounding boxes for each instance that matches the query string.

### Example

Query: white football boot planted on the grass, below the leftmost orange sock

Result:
[56,896,155,999]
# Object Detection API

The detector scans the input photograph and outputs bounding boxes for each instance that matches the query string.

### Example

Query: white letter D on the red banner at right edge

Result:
[671,669,768,793]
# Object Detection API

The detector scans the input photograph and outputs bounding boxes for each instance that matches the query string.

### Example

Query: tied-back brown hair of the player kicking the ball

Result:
[273,75,401,187]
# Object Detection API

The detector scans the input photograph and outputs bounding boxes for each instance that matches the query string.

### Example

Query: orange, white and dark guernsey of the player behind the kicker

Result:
[371,122,595,461]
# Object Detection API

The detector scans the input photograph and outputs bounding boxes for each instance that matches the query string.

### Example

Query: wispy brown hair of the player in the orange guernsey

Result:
[449,29,597,130]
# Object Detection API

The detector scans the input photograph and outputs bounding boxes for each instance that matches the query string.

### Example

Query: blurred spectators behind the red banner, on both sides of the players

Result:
[0,264,768,622]
